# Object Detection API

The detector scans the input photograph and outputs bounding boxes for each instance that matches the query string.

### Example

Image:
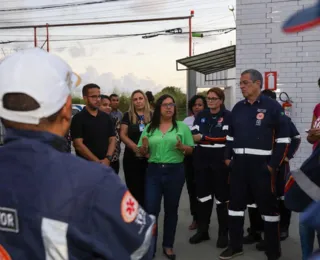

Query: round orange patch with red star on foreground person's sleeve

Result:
[120,191,139,223]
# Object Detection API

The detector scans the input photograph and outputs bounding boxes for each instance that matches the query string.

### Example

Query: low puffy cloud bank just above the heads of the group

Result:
[73,66,164,96]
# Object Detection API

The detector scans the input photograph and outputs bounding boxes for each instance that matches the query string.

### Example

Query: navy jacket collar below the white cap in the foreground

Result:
[4,128,67,152]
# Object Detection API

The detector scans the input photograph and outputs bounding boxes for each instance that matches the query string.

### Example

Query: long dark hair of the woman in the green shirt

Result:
[147,94,178,133]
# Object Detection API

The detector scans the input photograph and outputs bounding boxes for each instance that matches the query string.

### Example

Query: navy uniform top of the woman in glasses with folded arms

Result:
[191,109,231,148]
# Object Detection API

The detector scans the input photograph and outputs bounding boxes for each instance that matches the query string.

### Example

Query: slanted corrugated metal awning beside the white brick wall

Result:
[176,45,236,75]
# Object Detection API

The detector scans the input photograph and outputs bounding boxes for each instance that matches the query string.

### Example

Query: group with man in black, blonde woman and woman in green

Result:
[71,84,194,259]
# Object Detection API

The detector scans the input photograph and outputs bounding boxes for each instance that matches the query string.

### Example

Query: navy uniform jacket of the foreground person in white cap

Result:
[0,129,154,260]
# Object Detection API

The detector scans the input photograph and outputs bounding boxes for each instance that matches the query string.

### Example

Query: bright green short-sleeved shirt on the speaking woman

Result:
[138,121,194,163]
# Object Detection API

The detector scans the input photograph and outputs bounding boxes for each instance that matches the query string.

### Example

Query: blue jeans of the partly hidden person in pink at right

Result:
[299,214,320,260]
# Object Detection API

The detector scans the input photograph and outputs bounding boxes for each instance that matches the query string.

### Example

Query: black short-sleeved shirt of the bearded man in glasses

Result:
[71,108,116,160]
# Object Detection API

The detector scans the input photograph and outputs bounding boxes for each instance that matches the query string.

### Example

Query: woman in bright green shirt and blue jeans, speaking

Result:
[138,95,194,259]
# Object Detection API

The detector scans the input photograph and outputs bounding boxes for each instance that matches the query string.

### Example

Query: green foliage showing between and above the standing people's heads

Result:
[72,86,187,120]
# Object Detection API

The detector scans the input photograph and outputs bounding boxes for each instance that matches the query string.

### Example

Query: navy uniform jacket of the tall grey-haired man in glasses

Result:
[225,95,291,170]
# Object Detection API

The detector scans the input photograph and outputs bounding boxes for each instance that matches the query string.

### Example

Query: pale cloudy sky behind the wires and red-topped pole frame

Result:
[0,0,236,95]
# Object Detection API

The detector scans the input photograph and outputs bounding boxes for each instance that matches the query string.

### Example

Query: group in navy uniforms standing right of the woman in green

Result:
[184,70,301,260]
